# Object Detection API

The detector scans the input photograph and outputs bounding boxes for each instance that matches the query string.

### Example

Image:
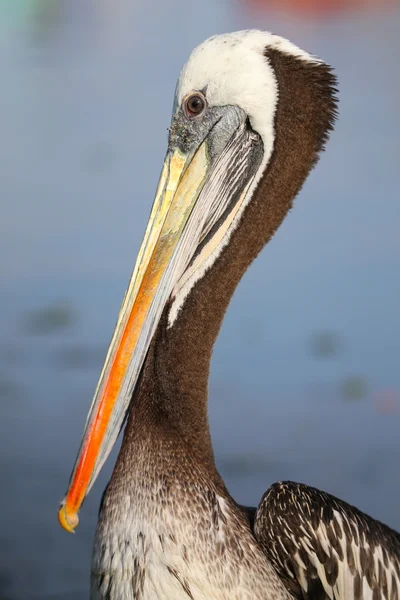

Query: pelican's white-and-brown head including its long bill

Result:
[59,31,335,531]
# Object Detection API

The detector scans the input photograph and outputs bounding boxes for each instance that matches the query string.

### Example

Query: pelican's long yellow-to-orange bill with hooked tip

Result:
[58,141,209,532]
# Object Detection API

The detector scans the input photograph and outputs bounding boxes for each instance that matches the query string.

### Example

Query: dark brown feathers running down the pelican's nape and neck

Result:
[127,49,336,461]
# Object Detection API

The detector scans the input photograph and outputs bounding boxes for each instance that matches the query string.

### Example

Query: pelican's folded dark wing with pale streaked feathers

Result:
[253,482,400,600]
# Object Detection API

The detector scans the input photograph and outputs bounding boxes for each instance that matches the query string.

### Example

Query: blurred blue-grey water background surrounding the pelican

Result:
[0,0,400,600]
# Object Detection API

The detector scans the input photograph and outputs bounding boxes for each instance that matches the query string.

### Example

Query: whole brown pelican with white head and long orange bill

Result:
[59,31,400,600]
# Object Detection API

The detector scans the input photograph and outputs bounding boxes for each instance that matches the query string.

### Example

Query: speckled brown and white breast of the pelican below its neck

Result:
[91,431,292,600]
